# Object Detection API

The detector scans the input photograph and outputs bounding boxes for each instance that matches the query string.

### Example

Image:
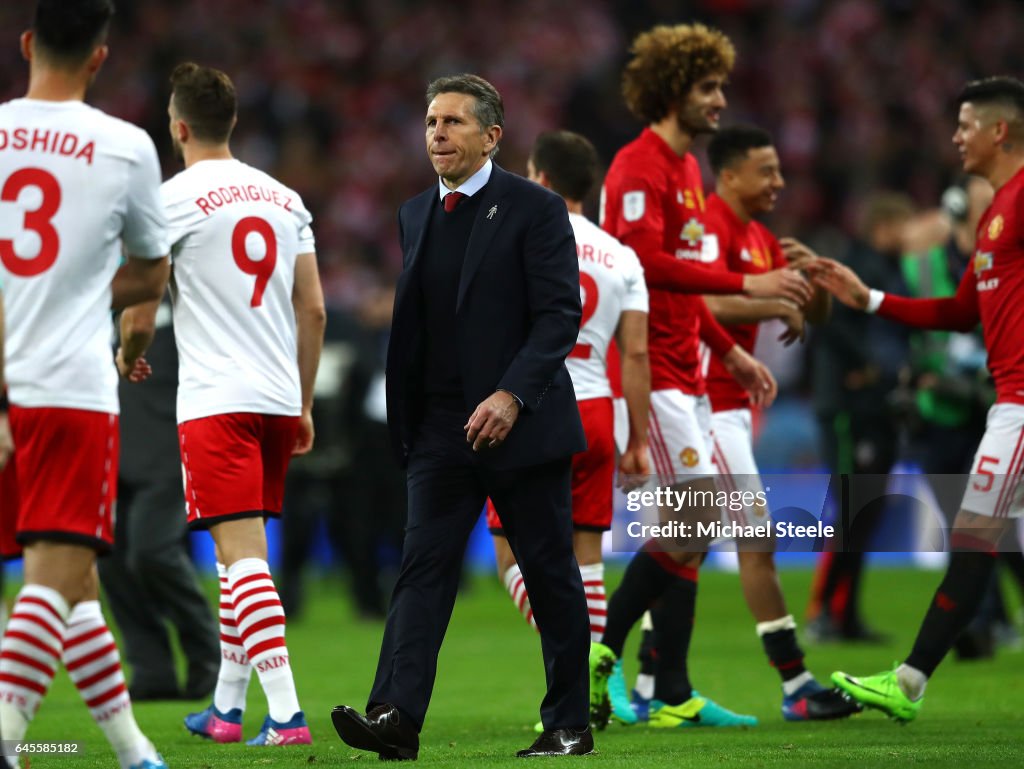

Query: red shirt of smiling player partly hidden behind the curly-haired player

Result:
[703,194,785,412]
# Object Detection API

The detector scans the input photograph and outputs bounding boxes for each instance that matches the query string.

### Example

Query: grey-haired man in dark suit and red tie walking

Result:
[332,75,594,759]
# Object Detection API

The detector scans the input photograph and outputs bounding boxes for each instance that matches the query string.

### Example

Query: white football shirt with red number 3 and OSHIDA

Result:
[0,98,168,414]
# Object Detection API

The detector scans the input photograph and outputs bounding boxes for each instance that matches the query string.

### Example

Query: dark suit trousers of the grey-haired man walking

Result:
[368,408,590,729]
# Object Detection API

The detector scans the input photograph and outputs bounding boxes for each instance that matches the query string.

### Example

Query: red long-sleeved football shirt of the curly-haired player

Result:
[601,128,743,395]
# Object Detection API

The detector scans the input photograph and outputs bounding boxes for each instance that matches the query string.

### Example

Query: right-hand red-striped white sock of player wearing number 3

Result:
[62,601,157,769]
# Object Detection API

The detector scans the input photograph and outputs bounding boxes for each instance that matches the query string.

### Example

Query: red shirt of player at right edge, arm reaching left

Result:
[879,169,1024,403]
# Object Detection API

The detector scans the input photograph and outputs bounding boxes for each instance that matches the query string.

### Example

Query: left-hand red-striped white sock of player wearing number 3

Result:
[0,585,70,740]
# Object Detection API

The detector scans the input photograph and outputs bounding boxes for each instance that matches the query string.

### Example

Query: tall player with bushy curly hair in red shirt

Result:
[591,24,811,728]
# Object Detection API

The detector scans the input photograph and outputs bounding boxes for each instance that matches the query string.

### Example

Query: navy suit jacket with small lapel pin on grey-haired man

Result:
[387,165,586,469]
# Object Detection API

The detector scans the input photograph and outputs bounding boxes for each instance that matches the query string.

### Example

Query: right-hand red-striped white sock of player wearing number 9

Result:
[227,558,301,722]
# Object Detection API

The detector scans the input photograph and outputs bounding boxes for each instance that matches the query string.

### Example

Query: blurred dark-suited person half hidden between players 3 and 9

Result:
[96,297,220,702]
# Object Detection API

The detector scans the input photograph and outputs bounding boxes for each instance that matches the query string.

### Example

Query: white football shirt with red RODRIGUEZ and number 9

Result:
[161,160,314,423]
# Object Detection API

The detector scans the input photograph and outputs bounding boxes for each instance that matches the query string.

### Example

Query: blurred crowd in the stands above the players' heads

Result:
[8,0,1024,309]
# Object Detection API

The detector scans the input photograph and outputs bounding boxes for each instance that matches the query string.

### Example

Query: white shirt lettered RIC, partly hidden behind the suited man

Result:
[565,214,647,400]
